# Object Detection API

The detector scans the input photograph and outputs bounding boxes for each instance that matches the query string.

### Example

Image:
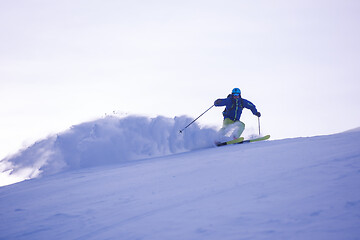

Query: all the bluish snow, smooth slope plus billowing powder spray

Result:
[0,117,360,240]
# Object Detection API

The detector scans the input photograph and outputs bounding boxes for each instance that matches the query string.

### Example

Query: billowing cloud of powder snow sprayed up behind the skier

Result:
[0,115,216,186]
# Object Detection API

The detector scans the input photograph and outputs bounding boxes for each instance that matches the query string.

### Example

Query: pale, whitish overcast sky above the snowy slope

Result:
[0,0,360,159]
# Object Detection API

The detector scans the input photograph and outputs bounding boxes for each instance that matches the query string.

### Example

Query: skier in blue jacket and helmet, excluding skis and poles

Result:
[214,88,261,139]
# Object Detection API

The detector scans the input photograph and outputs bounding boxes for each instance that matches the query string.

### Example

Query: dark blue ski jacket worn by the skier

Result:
[214,94,258,121]
